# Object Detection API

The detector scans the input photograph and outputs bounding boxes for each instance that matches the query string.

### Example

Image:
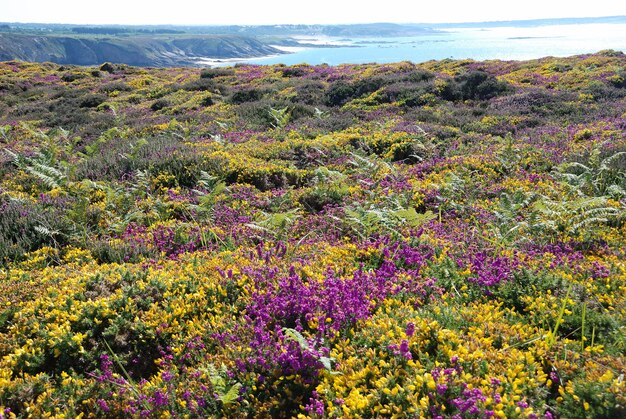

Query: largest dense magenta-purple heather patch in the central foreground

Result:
[236,239,435,380]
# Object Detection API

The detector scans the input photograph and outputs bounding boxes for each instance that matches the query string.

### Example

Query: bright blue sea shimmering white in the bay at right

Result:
[240,23,626,65]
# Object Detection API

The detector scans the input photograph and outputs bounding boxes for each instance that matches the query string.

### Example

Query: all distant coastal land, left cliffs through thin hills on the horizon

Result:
[0,16,626,67]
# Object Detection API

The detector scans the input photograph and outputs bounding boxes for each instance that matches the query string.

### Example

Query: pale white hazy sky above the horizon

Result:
[0,0,626,25]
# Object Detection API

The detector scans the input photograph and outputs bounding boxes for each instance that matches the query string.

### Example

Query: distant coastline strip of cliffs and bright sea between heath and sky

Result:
[0,16,626,67]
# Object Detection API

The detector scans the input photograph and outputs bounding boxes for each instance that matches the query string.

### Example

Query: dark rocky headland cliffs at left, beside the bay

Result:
[0,34,281,67]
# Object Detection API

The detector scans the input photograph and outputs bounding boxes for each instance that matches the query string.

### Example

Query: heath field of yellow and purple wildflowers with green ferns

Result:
[0,51,626,419]
